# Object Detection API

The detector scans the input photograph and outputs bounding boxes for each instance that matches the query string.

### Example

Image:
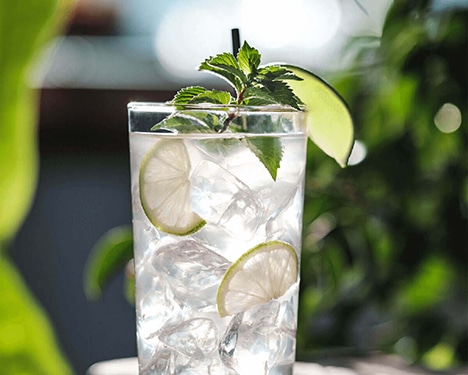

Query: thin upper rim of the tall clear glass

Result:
[127,101,306,113]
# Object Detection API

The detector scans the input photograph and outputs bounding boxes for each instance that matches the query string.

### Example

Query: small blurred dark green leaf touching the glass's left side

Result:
[84,226,133,299]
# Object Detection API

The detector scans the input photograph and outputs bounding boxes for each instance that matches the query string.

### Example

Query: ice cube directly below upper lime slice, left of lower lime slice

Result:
[152,240,231,311]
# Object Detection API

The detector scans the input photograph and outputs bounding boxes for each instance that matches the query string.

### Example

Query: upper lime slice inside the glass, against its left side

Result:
[139,139,206,236]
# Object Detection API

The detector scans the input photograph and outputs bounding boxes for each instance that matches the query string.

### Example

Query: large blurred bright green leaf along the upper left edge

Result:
[0,0,71,242]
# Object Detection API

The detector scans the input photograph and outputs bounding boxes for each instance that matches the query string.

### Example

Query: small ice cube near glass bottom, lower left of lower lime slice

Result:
[158,318,218,360]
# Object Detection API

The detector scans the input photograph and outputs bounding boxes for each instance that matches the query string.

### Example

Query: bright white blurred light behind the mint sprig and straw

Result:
[155,0,342,83]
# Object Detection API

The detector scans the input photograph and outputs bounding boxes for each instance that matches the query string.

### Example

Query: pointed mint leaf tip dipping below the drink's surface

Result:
[244,137,283,181]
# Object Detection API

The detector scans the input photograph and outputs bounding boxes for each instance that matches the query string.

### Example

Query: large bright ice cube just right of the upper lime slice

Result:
[191,160,264,239]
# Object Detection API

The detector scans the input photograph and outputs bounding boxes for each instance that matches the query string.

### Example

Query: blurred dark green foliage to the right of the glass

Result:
[298,0,468,370]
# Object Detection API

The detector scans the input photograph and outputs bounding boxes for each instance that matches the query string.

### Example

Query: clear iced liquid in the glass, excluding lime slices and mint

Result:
[130,133,306,375]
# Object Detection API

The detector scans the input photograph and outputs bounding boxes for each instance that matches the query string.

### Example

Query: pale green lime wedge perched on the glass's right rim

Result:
[284,65,354,167]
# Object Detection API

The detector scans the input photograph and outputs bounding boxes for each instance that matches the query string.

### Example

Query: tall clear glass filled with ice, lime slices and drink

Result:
[128,103,307,375]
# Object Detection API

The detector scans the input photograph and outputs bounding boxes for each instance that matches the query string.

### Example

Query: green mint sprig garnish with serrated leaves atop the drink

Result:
[152,42,303,180]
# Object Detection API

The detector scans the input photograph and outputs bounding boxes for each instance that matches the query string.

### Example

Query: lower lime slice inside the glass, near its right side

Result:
[216,241,298,317]
